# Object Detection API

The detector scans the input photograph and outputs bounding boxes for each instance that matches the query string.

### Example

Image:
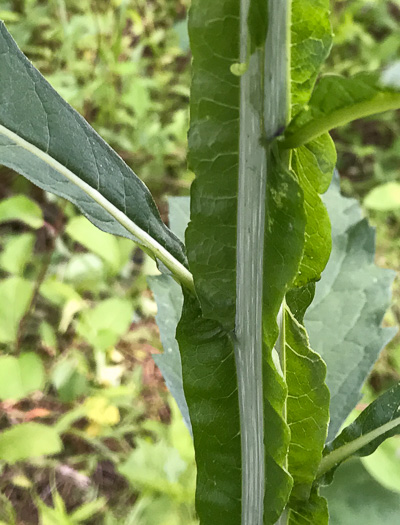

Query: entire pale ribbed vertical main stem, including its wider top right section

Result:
[235,0,290,525]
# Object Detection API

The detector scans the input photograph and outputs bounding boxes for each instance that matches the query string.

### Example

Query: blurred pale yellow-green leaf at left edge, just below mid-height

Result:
[0,277,33,343]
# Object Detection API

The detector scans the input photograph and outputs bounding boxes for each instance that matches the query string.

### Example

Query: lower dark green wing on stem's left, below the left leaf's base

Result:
[177,295,242,525]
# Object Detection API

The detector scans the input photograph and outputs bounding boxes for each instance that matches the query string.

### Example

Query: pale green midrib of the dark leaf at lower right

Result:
[317,417,400,478]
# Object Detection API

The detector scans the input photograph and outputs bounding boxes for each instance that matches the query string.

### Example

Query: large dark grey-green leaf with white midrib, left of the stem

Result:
[0,23,192,289]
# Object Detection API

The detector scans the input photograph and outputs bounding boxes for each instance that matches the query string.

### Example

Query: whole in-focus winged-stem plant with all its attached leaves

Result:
[0,0,400,525]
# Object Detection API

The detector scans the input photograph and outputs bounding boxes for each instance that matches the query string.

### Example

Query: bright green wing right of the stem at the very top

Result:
[290,0,332,117]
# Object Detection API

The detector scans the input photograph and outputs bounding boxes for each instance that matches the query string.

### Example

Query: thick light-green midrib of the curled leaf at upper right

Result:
[281,93,400,149]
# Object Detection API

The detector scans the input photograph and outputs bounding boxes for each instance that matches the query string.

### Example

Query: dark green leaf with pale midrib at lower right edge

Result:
[319,383,400,476]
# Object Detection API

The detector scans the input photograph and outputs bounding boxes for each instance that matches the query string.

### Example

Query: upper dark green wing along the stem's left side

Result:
[186,0,240,329]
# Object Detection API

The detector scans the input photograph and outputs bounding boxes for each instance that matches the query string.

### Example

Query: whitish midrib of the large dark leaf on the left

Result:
[0,124,194,291]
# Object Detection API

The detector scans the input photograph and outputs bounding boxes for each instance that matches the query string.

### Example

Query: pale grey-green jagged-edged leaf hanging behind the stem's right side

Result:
[304,177,396,440]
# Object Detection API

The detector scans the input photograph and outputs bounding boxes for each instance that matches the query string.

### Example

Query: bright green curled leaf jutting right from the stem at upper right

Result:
[283,73,400,148]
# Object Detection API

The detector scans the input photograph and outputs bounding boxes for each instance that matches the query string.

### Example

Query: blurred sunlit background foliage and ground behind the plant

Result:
[0,0,400,525]
